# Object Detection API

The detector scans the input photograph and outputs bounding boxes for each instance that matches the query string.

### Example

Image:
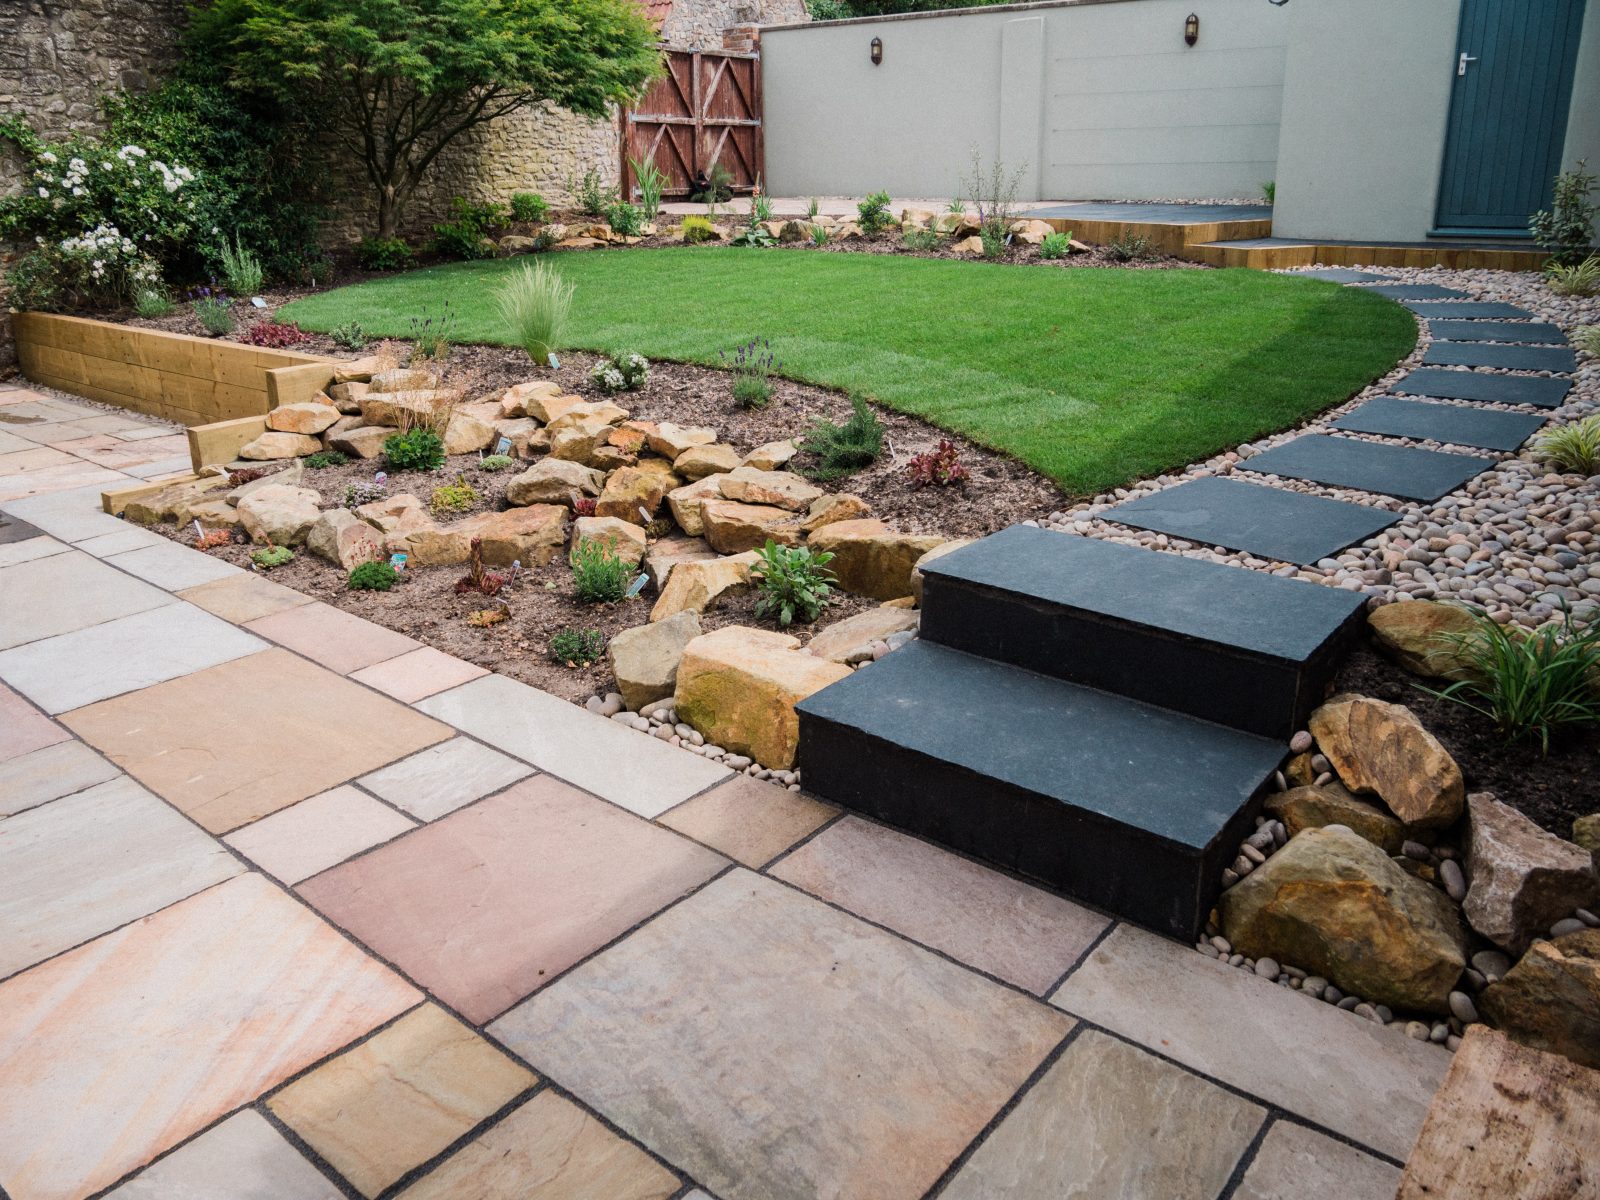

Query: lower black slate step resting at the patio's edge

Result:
[797,640,1283,939]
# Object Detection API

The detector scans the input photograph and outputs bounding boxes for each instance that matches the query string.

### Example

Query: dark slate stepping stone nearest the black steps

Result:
[1106,478,1400,565]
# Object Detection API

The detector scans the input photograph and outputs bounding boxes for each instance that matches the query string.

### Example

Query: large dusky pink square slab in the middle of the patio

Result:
[299,776,726,1024]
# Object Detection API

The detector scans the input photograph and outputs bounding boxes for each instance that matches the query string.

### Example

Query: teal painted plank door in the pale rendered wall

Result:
[1437,0,1584,237]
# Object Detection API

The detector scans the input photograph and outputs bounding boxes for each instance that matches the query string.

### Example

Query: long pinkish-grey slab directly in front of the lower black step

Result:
[773,816,1110,995]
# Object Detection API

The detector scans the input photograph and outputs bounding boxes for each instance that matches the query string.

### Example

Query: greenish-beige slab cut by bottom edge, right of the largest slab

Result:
[941,1029,1260,1200]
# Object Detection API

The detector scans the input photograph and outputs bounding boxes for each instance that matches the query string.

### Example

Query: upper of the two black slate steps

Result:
[922,525,1363,741]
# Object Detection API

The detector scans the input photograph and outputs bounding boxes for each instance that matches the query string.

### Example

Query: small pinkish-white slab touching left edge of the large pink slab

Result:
[222,786,416,883]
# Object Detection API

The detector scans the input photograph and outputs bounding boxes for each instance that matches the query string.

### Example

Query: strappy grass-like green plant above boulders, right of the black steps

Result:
[1424,608,1600,754]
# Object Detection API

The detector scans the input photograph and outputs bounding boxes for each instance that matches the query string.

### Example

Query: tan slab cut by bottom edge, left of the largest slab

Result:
[400,1091,680,1200]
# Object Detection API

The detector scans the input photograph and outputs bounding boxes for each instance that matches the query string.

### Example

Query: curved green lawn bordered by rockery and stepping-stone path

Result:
[283,248,1416,494]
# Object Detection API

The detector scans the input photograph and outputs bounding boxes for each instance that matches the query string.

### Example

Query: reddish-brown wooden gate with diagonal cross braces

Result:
[622,50,763,200]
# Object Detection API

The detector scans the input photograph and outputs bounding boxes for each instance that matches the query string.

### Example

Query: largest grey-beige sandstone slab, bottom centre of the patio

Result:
[492,870,1072,1200]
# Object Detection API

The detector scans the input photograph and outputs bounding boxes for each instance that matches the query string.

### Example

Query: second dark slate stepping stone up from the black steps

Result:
[1240,434,1494,501]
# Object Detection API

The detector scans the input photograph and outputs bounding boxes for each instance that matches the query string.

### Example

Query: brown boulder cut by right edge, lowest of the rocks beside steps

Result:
[1478,930,1600,1067]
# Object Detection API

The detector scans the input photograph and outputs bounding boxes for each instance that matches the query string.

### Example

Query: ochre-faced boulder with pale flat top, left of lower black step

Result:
[669,630,850,770]
